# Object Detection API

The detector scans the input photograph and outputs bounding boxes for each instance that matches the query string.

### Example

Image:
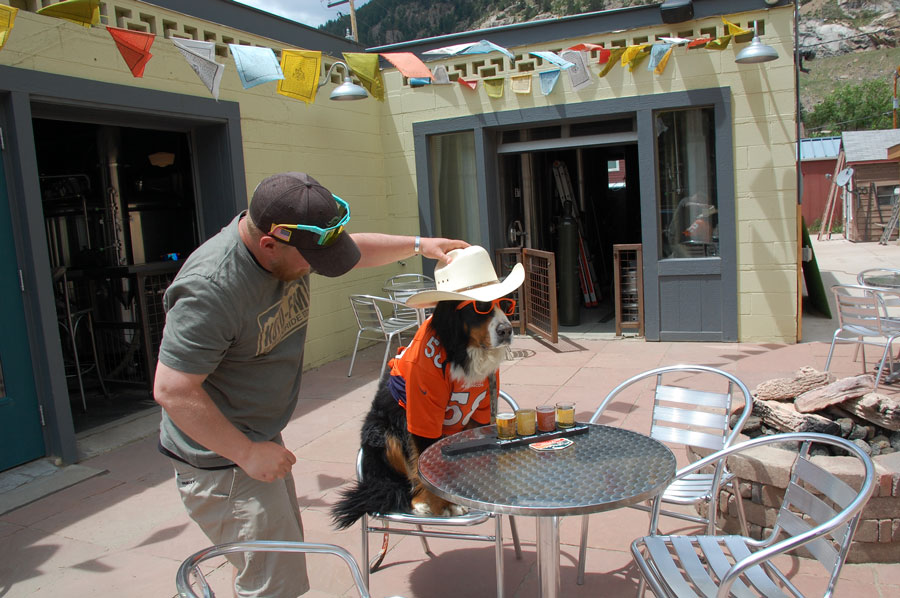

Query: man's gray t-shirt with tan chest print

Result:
[159,214,309,468]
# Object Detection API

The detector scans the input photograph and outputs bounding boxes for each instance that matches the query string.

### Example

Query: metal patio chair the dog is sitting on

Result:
[356,390,522,598]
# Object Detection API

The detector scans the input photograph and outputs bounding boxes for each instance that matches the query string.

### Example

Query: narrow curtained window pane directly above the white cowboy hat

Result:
[428,131,481,243]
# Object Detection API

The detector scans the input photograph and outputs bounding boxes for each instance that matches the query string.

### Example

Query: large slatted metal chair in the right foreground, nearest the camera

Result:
[631,432,875,598]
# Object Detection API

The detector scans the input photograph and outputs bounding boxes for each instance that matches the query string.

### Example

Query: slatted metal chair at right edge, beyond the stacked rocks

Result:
[825,284,900,392]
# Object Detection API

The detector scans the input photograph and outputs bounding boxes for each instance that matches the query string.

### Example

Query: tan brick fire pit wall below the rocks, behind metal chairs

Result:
[692,446,900,563]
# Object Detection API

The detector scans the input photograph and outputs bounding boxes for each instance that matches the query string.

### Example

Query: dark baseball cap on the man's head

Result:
[249,172,360,277]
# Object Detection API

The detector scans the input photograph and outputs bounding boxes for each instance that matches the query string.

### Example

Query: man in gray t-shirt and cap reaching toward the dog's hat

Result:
[153,172,468,597]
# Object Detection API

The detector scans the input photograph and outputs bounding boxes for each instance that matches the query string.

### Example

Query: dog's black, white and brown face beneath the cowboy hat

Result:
[431,301,513,384]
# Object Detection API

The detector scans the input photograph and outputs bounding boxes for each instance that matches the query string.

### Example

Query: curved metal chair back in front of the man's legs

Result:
[175,540,399,598]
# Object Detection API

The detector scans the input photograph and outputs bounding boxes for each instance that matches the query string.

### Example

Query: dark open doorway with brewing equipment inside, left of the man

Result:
[32,118,200,433]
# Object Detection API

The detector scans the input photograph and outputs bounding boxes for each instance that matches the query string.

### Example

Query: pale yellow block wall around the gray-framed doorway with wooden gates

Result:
[382,7,798,343]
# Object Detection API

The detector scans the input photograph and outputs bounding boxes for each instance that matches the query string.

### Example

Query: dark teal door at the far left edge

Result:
[0,149,45,471]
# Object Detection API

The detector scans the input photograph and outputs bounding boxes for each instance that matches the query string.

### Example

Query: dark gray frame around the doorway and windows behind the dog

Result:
[413,87,738,341]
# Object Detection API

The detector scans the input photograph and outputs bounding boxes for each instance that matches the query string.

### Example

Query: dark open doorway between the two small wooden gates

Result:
[500,143,642,333]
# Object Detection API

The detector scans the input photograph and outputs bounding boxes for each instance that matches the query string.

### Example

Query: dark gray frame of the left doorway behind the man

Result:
[0,66,247,463]
